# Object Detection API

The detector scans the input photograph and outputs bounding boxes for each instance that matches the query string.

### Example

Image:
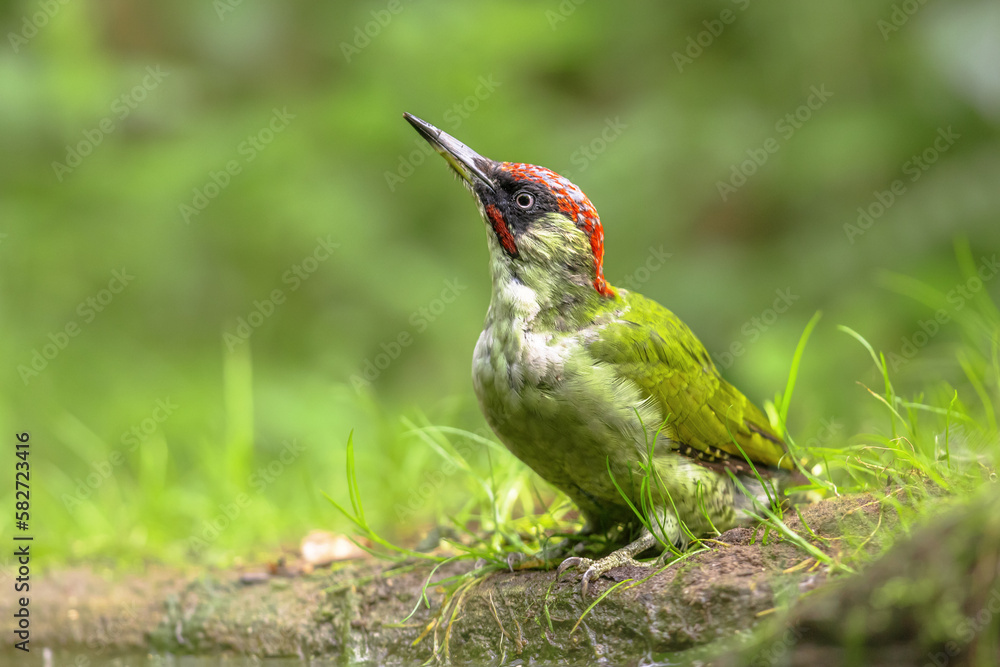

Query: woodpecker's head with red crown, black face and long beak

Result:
[403,114,615,308]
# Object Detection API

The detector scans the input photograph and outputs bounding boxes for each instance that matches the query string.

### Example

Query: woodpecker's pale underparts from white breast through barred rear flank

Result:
[472,318,752,543]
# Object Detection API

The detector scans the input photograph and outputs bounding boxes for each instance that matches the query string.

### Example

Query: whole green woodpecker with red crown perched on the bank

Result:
[404,114,793,593]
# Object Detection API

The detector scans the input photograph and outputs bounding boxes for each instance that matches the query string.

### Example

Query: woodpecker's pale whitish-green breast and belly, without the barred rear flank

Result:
[472,322,662,520]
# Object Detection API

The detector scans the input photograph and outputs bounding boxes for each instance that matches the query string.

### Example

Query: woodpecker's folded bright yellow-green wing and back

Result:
[589,292,792,468]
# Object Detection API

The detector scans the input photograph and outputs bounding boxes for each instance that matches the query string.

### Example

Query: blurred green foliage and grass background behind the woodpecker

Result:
[0,0,1000,565]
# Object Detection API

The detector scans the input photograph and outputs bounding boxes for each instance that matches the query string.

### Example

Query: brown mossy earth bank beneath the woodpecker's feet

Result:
[0,494,944,664]
